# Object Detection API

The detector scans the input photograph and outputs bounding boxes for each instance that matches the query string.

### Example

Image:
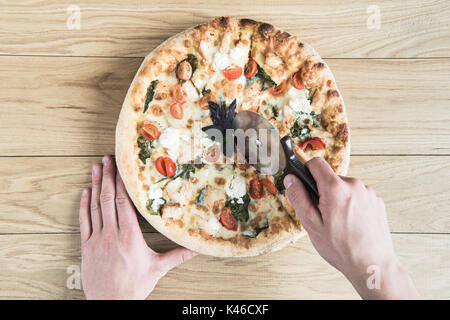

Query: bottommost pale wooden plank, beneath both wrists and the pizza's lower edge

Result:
[0,233,450,300]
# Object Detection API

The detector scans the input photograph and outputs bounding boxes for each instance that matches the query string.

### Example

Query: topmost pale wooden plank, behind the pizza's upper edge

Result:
[0,0,450,58]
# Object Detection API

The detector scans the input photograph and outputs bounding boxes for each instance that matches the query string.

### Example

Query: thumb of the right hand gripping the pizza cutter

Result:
[284,174,322,231]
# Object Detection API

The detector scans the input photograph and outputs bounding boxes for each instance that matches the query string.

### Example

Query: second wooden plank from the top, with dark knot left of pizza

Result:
[0,57,450,156]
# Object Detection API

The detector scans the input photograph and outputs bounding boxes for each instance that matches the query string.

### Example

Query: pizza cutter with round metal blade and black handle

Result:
[233,110,319,206]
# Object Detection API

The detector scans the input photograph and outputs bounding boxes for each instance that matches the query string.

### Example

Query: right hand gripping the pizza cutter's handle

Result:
[284,158,418,299]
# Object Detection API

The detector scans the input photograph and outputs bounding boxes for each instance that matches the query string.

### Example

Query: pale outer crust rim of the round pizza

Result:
[115,18,350,257]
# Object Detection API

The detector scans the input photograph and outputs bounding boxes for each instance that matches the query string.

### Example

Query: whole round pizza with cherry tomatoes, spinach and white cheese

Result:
[116,17,350,257]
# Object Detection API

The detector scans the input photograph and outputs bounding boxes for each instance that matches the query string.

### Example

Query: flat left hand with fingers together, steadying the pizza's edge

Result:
[80,156,196,299]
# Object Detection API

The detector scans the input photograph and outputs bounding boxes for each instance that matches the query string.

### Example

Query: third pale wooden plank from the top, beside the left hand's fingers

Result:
[0,156,450,233]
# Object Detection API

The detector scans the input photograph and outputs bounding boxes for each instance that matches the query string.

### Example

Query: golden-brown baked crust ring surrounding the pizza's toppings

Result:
[116,17,350,257]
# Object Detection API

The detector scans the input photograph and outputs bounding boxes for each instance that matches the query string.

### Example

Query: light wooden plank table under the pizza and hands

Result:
[0,0,450,299]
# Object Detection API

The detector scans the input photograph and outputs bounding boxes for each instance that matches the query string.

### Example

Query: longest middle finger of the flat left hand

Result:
[100,156,118,230]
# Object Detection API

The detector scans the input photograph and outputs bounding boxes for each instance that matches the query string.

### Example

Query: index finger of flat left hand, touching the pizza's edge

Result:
[116,171,139,231]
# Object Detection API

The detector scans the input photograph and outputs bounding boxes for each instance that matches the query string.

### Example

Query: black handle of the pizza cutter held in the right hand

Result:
[280,136,319,207]
